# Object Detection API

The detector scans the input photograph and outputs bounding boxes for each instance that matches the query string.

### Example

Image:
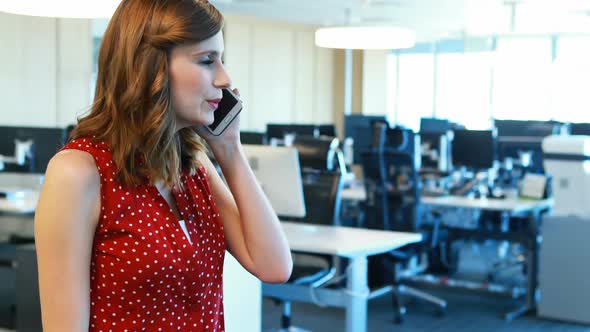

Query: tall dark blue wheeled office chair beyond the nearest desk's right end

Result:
[361,123,447,323]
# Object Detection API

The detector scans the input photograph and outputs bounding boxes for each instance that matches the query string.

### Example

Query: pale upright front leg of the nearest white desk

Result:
[346,257,369,332]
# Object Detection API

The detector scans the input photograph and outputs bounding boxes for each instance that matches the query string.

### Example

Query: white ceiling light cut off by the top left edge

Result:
[0,0,121,18]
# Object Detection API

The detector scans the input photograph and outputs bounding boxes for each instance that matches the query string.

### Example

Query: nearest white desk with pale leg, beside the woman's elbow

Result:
[262,222,422,332]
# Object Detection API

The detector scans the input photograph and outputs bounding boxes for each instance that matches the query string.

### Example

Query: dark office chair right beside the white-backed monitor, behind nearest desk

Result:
[280,136,346,332]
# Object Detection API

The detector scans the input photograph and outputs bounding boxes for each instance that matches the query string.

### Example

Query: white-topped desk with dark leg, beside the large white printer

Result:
[420,196,553,320]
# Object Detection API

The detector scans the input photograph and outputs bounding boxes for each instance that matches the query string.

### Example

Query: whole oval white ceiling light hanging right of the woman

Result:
[315,26,416,50]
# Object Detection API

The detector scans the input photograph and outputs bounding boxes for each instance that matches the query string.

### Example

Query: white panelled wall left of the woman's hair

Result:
[0,13,92,127]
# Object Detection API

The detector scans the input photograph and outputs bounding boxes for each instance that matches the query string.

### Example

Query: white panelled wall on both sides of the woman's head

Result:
[0,13,334,130]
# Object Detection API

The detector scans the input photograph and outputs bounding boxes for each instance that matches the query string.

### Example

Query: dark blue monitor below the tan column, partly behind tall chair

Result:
[344,114,389,164]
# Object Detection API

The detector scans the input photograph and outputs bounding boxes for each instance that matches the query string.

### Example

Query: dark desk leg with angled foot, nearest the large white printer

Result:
[505,211,542,321]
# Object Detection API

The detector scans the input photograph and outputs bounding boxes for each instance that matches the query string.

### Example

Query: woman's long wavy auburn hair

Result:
[71,0,223,186]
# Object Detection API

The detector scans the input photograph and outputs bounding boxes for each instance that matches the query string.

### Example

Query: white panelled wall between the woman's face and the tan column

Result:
[225,16,334,130]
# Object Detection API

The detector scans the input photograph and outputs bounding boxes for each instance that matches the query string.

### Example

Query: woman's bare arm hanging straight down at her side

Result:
[35,150,100,332]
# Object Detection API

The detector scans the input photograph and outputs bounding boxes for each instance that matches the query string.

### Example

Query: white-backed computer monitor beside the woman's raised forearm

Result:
[243,144,306,218]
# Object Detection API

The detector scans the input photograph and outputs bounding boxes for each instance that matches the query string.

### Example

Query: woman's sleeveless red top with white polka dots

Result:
[63,138,225,332]
